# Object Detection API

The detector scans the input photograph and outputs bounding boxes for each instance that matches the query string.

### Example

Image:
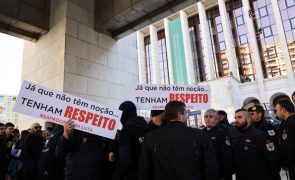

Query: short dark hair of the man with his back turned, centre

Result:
[165,101,185,121]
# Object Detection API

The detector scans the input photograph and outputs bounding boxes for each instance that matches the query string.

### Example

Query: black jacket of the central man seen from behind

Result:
[138,121,218,180]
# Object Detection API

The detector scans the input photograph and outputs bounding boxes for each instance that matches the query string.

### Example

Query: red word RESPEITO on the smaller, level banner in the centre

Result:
[169,93,209,103]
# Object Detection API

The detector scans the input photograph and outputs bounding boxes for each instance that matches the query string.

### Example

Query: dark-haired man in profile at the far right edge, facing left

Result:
[276,99,295,180]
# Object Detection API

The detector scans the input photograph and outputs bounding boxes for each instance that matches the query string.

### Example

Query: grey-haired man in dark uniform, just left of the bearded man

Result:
[204,109,233,180]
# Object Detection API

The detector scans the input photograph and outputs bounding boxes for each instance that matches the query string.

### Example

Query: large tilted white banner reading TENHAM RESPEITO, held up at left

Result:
[13,81,122,139]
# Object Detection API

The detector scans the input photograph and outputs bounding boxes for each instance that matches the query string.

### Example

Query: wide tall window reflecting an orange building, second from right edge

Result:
[250,0,287,78]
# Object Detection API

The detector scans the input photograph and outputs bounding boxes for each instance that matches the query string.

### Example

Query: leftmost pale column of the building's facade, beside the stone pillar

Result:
[136,31,147,84]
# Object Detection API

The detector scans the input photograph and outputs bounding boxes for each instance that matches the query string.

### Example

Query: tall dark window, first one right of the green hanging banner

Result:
[188,15,207,82]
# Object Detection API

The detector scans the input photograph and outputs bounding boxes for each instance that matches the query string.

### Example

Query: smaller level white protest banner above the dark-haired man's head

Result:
[133,84,211,110]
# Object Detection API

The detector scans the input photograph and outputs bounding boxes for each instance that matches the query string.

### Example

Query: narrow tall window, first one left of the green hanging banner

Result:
[158,29,169,84]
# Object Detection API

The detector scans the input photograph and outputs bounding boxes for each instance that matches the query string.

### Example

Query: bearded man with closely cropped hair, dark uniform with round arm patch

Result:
[233,109,280,180]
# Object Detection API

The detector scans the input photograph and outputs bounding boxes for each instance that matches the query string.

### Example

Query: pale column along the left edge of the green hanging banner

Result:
[164,18,174,84]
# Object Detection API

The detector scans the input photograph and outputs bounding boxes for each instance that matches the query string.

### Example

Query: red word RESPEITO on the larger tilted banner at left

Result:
[64,106,116,131]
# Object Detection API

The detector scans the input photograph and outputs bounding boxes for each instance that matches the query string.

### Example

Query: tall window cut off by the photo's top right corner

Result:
[278,0,295,73]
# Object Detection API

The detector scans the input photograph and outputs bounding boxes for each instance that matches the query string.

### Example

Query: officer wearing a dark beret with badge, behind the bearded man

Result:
[248,105,279,146]
